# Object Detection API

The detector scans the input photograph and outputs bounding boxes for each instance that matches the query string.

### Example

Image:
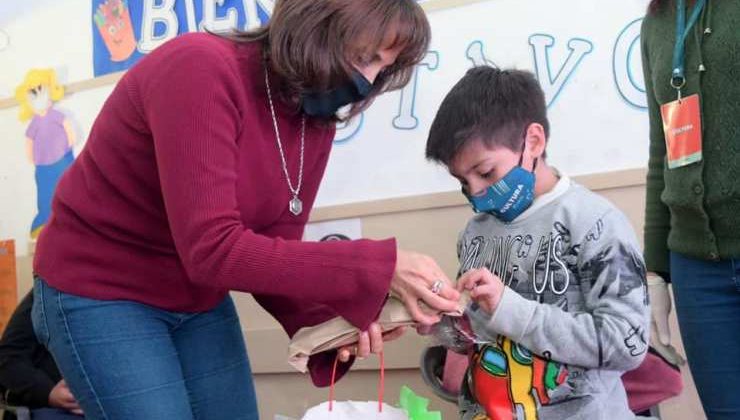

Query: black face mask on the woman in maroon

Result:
[302,71,373,118]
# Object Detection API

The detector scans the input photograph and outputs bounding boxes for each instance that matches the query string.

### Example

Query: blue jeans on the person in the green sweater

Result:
[671,252,740,420]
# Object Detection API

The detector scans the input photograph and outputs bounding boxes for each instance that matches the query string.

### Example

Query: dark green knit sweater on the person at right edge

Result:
[641,0,740,273]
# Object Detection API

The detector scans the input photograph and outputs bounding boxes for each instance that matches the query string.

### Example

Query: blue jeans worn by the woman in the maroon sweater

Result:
[31,278,258,420]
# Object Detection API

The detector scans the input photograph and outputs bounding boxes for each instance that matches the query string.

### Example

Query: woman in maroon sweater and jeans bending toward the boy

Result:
[33,0,459,420]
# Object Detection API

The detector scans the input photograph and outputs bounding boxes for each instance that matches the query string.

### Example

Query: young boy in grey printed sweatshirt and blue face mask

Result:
[426,67,649,420]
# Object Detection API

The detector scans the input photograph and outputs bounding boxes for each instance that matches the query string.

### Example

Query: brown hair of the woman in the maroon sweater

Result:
[229,0,431,120]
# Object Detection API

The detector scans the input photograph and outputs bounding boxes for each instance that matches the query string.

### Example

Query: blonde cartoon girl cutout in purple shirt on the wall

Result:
[15,69,75,239]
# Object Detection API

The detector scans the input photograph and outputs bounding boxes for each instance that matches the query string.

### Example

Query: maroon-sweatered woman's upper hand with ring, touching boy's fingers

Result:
[391,249,460,325]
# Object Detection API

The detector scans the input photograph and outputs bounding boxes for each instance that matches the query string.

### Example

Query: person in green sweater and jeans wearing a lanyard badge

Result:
[641,0,740,419]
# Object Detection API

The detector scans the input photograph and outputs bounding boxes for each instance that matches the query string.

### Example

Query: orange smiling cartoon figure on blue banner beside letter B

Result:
[93,0,136,61]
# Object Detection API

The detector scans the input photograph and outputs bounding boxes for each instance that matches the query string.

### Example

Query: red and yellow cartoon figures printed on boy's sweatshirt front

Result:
[468,337,568,420]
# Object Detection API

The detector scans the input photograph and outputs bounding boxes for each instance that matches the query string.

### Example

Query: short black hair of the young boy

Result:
[426,66,550,165]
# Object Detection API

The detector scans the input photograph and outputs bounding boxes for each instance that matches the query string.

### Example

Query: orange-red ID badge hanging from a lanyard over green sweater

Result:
[660,94,701,169]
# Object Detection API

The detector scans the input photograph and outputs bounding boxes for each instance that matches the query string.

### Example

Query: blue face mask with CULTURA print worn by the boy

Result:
[463,143,537,223]
